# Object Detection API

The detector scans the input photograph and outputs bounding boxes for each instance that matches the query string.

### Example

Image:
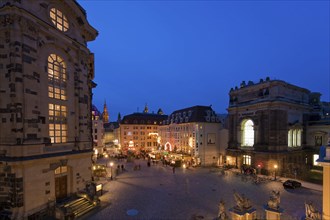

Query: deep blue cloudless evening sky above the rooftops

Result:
[78,0,330,121]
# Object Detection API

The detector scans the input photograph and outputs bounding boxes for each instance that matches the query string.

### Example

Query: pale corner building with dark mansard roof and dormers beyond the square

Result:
[159,106,227,166]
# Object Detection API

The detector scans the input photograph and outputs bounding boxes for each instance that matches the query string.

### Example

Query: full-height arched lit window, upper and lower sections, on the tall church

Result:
[47,54,68,143]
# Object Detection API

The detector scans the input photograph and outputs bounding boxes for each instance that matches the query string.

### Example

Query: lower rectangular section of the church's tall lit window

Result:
[48,104,68,143]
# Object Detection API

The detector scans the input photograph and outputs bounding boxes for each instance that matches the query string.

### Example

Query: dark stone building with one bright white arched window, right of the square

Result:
[226,77,329,177]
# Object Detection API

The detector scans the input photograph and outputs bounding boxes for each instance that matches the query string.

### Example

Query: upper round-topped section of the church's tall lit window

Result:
[47,54,67,100]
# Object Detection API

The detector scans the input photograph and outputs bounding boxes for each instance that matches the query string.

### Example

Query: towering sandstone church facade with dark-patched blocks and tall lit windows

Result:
[0,0,97,219]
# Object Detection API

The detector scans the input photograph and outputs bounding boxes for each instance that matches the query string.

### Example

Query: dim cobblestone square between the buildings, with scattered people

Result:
[84,160,322,220]
